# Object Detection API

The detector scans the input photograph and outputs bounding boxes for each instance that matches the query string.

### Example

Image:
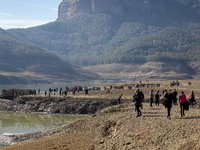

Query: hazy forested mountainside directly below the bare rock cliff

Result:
[8,0,200,65]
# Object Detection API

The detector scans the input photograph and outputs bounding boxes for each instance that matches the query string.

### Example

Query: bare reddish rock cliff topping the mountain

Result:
[58,0,199,19]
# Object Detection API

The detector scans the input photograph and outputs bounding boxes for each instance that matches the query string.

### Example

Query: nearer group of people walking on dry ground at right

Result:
[118,89,197,119]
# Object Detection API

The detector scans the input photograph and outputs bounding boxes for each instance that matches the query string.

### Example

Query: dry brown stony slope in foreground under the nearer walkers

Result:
[2,103,200,150]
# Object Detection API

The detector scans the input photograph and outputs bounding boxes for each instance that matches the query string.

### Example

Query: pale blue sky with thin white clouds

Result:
[0,0,62,29]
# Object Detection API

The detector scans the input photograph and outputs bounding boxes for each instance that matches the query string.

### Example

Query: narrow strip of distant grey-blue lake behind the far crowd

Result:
[0,83,99,94]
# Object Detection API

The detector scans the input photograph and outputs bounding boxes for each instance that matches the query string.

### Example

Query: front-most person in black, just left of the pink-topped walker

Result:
[164,90,173,119]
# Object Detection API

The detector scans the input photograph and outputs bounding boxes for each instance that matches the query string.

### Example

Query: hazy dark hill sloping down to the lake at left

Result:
[0,29,97,84]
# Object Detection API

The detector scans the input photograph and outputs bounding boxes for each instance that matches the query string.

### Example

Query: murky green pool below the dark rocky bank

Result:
[0,113,86,135]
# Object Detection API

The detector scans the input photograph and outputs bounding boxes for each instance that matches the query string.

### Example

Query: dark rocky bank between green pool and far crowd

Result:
[0,97,123,114]
